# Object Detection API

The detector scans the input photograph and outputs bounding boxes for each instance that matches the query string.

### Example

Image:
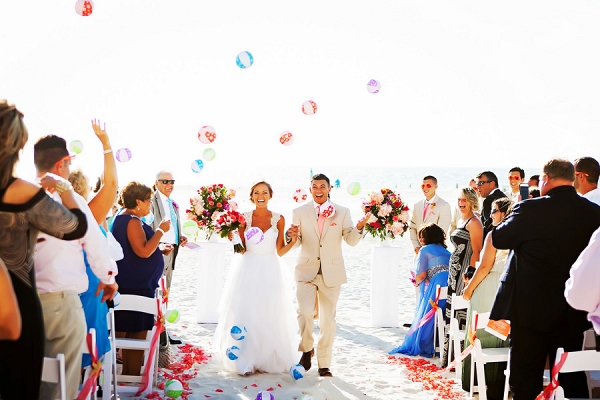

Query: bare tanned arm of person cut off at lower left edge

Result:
[0,258,21,340]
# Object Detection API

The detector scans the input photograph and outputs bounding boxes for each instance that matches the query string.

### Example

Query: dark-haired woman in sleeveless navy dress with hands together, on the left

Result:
[112,182,173,375]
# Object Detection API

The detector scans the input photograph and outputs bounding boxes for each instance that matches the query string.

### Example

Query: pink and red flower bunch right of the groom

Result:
[362,188,409,241]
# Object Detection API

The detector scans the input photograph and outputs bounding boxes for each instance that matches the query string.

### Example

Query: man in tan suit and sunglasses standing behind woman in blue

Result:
[409,175,452,254]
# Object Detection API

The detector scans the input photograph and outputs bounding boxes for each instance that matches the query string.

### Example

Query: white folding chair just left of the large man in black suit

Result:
[469,310,510,400]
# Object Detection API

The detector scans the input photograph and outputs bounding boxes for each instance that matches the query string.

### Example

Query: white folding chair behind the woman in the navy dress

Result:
[114,294,162,395]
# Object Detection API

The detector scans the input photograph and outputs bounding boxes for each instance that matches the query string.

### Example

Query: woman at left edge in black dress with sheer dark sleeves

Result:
[0,100,87,399]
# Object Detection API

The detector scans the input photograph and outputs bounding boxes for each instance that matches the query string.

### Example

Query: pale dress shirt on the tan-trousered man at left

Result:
[34,192,118,294]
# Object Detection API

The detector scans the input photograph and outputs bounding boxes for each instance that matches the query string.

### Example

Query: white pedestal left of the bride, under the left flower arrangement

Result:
[196,242,231,324]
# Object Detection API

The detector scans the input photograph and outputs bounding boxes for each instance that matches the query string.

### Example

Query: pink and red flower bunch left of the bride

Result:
[185,183,246,247]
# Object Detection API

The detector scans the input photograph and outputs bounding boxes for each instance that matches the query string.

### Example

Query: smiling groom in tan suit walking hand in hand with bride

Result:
[286,174,368,377]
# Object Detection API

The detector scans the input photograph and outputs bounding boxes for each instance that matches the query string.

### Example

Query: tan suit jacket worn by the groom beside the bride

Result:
[292,201,362,287]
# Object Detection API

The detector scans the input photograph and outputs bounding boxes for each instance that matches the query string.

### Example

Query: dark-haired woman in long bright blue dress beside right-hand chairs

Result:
[389,223,450,358]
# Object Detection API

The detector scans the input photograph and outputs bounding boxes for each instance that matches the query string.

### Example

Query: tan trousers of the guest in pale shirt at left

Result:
[40,291,87,400]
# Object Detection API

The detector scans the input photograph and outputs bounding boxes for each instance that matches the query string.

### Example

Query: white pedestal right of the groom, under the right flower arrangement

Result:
[371,246,402,328]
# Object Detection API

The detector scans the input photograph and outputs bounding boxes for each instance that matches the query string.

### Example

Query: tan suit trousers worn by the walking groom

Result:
[296,274,341,368]
